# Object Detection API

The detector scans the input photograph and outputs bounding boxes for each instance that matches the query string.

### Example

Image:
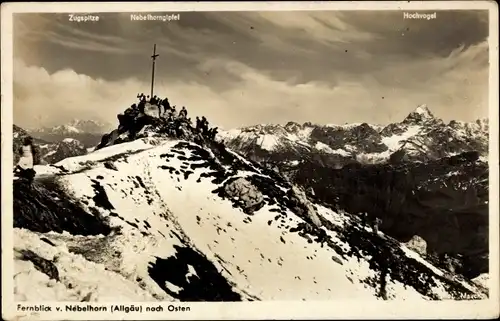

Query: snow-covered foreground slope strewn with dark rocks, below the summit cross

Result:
[14,133,487,302]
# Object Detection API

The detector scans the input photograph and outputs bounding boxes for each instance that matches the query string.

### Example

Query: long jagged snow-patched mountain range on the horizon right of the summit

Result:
[218,105,488,167]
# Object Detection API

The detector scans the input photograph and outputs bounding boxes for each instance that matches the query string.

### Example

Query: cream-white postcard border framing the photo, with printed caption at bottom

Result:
[1,1,500,320]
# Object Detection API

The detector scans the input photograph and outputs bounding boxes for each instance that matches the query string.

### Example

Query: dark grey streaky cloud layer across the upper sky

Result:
[15,11,487,91]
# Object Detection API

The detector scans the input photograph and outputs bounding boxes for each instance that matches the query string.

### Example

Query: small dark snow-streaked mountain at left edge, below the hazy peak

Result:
[13,125,88,164]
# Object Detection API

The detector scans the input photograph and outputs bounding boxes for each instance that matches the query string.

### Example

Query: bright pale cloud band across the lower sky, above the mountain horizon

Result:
[14,37,488,128]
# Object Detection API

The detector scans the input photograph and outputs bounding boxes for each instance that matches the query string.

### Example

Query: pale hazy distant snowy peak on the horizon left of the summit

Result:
[29,119,111,148]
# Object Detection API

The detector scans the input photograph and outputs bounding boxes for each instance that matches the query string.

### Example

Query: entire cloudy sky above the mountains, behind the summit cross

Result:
[13,11,489,129]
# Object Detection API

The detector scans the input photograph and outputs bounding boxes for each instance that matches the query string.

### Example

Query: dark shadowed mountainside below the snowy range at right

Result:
[294,152,488,276]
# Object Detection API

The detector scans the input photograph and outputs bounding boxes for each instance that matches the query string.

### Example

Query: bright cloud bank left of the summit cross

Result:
[14,60,141,128]
